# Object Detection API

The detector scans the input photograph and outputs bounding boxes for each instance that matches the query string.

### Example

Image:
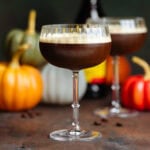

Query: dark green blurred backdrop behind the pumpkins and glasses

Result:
[0,0,150,73]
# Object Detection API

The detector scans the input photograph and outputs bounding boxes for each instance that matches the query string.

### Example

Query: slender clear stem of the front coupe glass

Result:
[72,71,80,132]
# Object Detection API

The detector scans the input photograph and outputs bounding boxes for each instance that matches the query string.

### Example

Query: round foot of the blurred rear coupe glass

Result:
[94,107,138,118]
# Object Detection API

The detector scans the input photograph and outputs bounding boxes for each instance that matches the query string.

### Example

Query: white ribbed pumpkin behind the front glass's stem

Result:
[41,64,87,105]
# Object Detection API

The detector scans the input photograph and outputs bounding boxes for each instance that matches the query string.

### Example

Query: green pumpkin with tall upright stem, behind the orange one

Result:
[6,10,46,67]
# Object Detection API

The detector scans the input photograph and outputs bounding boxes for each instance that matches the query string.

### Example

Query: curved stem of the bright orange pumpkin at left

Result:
[10,44,29,67]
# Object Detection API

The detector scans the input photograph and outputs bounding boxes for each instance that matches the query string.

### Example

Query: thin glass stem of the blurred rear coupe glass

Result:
[111,56,120,110]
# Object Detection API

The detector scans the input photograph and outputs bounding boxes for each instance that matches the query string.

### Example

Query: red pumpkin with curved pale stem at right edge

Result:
[121,57,150,111]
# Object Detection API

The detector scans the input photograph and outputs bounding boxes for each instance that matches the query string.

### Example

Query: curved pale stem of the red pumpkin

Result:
[132,56,150,80]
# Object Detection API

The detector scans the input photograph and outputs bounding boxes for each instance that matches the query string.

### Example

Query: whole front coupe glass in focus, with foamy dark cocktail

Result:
[40,24,111,141]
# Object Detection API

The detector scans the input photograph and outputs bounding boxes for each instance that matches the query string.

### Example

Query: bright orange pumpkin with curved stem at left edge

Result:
[0,45,43,111]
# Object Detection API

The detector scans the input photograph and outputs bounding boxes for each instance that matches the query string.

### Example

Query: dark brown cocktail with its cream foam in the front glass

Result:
[40,25,111,70]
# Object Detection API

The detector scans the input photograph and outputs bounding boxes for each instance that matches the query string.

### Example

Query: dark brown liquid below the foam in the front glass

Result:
[40,42,111,70]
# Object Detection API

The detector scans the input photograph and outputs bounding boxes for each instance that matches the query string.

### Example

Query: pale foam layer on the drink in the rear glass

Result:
[109,24,147,34]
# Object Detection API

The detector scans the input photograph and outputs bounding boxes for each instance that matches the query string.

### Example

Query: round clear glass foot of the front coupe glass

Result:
[49,129,102,141]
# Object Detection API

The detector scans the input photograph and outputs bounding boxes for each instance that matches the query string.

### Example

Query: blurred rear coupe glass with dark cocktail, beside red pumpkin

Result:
[95,17,147,117]
